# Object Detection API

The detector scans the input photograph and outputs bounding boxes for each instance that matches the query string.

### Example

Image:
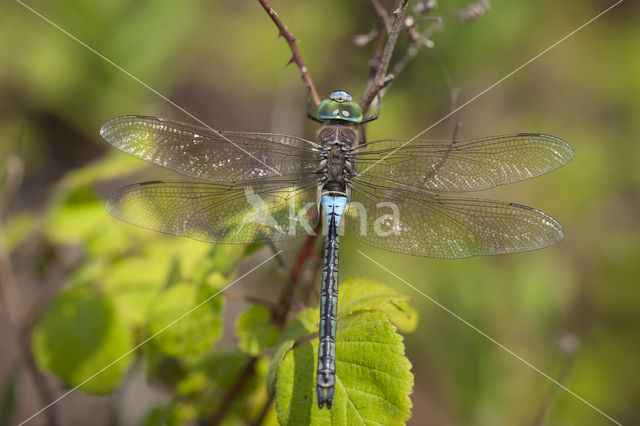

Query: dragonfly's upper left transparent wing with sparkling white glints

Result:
[100,115,320,182]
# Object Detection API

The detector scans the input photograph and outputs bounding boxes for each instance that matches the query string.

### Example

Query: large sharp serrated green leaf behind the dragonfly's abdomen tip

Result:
[276,311,413,425]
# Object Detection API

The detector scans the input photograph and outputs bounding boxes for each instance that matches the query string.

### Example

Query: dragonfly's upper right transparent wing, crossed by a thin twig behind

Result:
[352,133,573,192]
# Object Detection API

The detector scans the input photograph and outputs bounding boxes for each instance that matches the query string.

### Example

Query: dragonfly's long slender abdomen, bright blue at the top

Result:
[316,192,347,408]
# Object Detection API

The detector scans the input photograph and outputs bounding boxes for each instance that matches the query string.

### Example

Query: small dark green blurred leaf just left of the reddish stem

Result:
[236,305,279,356]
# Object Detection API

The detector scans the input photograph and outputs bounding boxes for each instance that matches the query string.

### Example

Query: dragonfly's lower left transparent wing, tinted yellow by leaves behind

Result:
[105,181,318,243]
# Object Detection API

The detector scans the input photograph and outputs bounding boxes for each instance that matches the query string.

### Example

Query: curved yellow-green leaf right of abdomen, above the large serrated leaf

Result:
[338,279,418,332]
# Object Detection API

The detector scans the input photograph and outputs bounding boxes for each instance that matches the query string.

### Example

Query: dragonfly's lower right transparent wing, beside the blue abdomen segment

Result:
[345,181,564,258]
